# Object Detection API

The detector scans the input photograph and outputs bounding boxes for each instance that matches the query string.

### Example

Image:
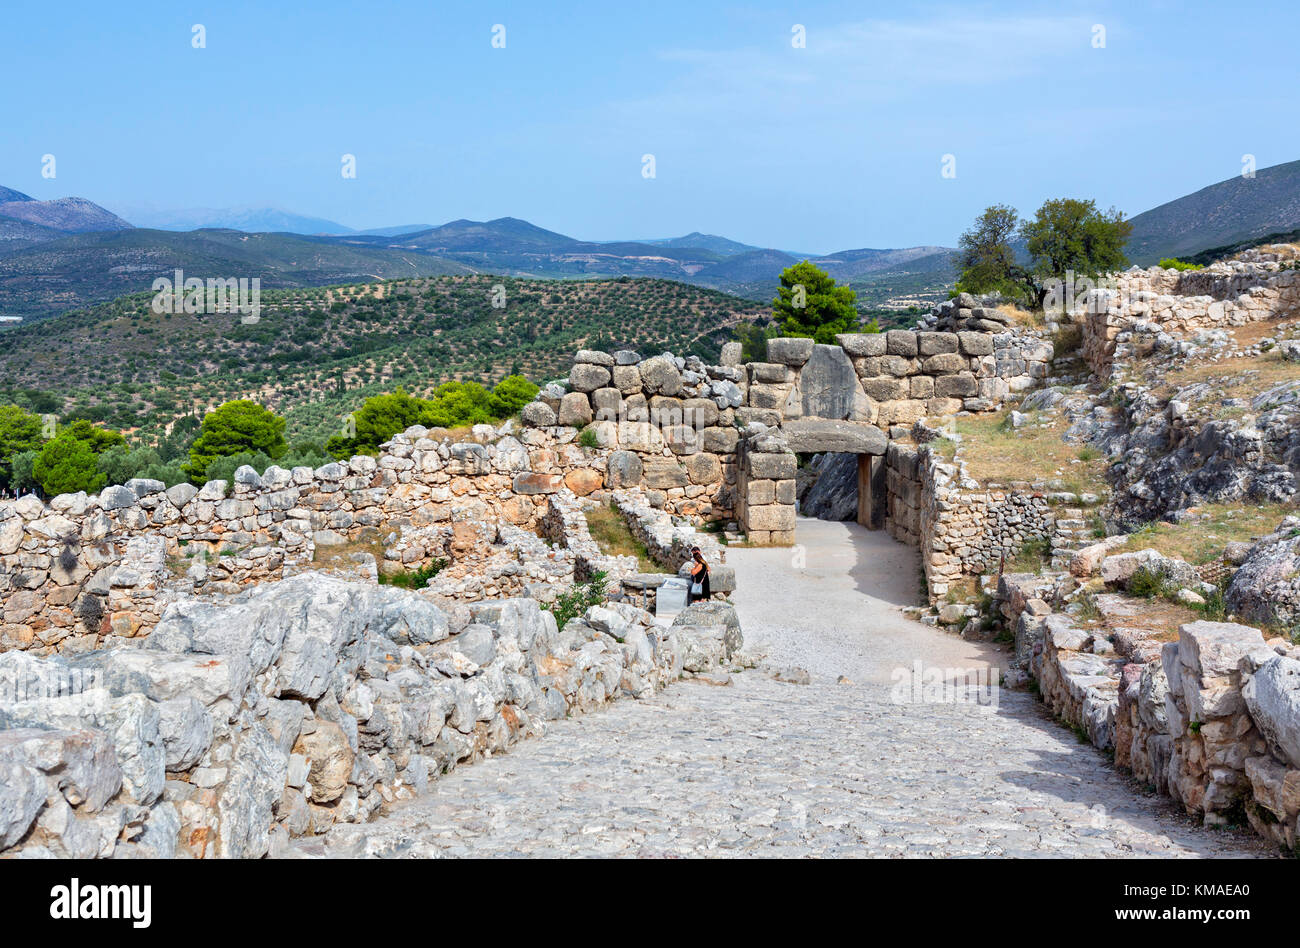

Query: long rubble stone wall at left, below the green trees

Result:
[0,427,608,652]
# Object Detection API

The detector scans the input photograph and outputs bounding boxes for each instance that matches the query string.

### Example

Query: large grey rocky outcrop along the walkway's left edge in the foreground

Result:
[0,573,740,858]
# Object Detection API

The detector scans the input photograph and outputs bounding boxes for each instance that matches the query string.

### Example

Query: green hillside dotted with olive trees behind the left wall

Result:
[0,276,770,442]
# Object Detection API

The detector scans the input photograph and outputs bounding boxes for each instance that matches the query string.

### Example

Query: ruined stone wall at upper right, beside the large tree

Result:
[1083,252,1300,382]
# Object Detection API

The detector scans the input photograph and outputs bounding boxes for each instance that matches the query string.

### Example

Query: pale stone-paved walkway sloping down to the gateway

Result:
[296,520,1269,857]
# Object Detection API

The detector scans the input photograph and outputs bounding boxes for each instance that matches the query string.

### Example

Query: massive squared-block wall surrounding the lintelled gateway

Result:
[523,327,1053,545]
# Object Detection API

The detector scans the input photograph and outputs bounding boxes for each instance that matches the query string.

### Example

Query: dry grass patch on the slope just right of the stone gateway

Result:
[957,411,1106,493]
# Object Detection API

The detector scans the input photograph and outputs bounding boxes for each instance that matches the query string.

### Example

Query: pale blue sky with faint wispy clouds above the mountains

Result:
[0,0,1300,252]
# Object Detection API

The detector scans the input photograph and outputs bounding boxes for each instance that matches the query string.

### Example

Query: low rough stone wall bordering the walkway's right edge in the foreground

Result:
[997,573,1300,849]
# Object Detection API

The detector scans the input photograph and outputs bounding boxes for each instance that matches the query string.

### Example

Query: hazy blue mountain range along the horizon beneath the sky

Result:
[0,161,1300,325]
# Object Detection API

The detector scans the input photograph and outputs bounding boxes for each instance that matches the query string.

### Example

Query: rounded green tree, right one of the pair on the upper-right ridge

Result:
[1021,198,1134,280]
